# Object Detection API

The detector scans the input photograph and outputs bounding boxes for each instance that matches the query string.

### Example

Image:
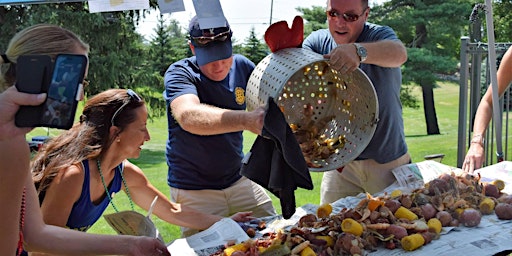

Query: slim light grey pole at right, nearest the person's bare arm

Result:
[485,0,503,162]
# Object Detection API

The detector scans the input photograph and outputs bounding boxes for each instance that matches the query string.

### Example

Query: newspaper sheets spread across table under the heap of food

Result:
[168,160,512,256]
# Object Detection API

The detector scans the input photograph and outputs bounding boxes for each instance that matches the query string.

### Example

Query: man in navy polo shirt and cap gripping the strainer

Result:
[164,17,276,236]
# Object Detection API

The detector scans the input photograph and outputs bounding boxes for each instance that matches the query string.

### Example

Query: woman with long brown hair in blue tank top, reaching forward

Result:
[32,89,251,249]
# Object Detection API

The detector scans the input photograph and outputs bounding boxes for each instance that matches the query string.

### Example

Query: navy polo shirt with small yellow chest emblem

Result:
[164,54,255,190]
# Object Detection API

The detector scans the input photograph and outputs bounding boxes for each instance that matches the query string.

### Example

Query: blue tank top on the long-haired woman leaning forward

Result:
[66,159,124,232]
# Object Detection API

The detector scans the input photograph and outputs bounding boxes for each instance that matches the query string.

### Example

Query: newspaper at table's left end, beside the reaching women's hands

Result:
[167,218,249,256]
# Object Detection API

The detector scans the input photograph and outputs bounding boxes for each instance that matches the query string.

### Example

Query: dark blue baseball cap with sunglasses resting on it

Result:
[188,16,233,66]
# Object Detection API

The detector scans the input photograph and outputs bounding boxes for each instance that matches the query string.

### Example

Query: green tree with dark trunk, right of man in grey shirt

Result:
[370,0,473,135]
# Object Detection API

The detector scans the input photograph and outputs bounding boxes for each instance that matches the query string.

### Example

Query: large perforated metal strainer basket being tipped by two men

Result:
[246,48,379,171]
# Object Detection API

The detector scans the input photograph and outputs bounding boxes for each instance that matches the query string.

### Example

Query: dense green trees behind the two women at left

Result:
[0,1,165,119]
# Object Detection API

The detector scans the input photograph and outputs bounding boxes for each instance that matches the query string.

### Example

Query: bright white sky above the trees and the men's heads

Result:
[138,0,383,42]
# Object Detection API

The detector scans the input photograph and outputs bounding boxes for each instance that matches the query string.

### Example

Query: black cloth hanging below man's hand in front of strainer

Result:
[241,98,313,219]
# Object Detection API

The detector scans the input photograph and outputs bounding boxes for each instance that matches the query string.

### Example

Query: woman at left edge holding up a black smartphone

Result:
[0,24,170,255]
